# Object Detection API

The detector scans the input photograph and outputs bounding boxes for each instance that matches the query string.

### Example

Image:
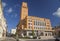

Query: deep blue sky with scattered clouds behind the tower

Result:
[2,0,60,32]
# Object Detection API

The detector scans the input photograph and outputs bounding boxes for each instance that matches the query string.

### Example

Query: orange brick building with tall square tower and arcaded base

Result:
[17,2,54,37]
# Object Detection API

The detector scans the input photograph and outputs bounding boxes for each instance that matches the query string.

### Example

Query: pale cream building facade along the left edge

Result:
[0,0,7,38]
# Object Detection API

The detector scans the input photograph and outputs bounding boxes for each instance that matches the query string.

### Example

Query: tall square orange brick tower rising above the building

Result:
[20,2,28,20]
